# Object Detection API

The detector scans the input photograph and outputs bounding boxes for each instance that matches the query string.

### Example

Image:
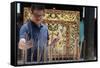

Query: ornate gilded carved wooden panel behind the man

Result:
[24,8,80,60]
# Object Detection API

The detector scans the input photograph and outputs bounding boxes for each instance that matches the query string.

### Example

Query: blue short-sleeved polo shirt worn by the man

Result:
[19,21,48,60]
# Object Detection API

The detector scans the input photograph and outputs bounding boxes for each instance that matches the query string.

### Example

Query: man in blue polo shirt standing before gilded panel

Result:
[19,4,59,62]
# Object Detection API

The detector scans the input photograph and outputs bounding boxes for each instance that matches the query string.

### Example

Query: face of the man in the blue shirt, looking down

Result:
[32,10,44,24]
